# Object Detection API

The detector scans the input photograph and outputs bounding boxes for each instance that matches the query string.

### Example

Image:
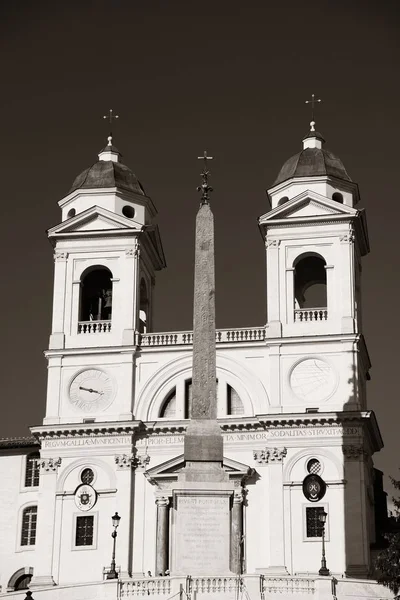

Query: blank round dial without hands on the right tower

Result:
[289,358,336,404]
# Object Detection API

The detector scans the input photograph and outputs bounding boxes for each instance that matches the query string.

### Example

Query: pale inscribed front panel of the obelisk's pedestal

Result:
[174,495,230,575]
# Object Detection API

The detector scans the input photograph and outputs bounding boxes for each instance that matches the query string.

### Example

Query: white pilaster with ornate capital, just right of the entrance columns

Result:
[254,448,287,574]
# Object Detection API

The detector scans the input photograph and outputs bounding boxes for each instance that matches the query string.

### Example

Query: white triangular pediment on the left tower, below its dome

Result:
[48,206,142,237]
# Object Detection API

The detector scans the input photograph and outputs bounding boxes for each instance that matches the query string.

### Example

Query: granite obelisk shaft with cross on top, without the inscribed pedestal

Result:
[184,152,224,480]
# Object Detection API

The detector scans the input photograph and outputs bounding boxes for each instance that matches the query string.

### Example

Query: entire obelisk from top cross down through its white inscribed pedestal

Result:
[172,152,233,576]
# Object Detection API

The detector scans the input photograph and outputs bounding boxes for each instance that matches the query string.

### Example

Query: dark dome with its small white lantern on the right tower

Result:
[273,129,351,186]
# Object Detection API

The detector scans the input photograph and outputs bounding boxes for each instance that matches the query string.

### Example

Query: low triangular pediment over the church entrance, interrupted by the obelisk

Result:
[146,454,254,488]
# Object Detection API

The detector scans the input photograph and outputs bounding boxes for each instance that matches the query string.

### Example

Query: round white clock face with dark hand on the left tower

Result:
[69,369,115,413]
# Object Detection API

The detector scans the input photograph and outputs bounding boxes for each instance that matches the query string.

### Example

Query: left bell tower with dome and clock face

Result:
[44,136,165,424]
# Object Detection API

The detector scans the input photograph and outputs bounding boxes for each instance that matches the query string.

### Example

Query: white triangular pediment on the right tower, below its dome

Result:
[260,191,357,224]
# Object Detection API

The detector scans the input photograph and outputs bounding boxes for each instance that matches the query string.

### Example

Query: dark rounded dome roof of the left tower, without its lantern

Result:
[69,160,145,196]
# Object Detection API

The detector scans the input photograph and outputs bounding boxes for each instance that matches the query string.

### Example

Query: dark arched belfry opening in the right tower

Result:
[294,254,327,318]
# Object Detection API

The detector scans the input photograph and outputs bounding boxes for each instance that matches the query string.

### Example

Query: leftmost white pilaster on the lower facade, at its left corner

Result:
[29,458,61,588]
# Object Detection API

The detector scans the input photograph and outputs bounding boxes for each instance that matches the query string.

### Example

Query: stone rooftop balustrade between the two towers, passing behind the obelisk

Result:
[137,327,265,347]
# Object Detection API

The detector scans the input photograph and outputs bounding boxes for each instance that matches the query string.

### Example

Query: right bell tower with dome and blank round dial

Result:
[259,121,370,412]
